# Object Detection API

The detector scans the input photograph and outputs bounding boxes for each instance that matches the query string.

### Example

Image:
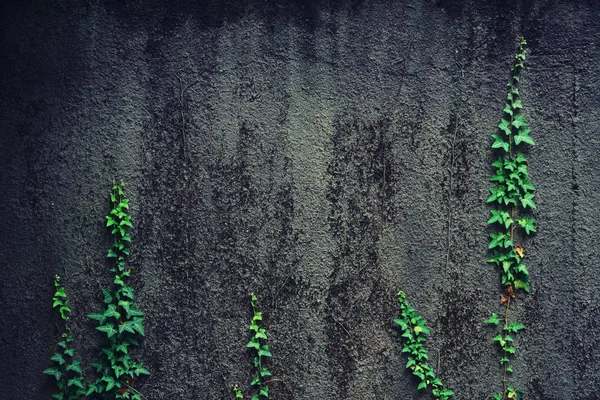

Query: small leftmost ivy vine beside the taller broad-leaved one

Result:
[44,275,85,400]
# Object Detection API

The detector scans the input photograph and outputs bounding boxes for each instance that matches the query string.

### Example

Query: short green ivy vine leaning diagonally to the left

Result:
[394,291,454,400]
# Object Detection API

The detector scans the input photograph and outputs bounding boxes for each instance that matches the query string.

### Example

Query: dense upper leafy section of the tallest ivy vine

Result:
[487,39,536,292]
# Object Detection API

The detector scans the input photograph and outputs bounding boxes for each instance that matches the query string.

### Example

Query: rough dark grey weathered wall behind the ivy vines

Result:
[0,0,600,400]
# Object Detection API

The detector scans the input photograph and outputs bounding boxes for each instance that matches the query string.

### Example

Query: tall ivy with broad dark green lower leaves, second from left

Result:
[86,181,150,400]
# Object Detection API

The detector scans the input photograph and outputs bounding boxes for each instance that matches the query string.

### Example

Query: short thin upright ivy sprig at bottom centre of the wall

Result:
[233,293,272,400]
